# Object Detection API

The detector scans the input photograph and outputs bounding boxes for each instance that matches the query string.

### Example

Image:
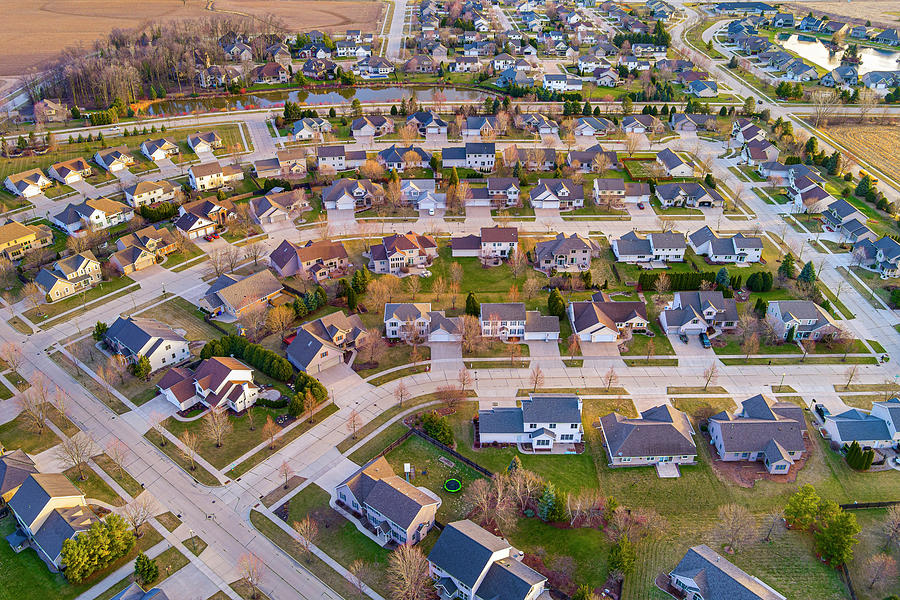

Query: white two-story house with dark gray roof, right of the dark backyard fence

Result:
[478,394,583,452]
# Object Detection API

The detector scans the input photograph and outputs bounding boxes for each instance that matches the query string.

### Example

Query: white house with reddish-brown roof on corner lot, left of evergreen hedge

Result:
[156,356,259,413]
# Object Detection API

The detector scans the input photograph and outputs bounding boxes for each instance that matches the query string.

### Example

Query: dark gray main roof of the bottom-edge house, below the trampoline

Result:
[428,520,510,588]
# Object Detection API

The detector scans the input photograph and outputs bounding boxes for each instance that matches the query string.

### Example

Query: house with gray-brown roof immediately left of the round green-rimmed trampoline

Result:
[334,456,441,547]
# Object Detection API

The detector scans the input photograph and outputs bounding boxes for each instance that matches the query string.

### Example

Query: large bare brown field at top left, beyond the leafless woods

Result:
[0,0,386,76]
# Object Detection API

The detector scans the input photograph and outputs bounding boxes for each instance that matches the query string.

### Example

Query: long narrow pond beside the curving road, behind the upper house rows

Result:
[148,87,488,115]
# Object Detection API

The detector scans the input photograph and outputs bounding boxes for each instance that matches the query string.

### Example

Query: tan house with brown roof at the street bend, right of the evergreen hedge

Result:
[287,311,366,373]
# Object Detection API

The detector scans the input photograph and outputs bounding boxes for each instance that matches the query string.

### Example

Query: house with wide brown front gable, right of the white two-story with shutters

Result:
[566,292,648,342]
